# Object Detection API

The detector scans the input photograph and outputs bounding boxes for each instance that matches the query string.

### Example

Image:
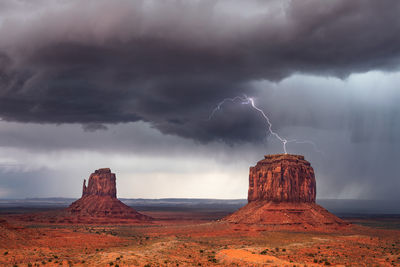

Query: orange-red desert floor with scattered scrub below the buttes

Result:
[0,211,400,266]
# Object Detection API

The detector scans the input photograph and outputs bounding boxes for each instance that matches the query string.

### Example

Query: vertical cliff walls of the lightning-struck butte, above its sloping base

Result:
[247,154,316,203]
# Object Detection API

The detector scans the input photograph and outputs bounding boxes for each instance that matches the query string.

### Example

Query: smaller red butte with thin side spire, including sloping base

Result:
[66,168,151,222]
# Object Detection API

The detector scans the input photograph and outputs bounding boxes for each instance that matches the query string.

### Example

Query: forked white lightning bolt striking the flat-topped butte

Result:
[208,95,323,154]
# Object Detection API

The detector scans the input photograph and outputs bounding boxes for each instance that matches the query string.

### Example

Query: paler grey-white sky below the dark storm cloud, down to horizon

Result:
[0,72,400,201]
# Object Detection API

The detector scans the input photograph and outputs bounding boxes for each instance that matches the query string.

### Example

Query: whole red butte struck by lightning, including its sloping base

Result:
[224,154,348,230]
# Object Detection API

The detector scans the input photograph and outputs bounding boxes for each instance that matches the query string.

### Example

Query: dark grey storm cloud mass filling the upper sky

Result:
[0,0,400,142]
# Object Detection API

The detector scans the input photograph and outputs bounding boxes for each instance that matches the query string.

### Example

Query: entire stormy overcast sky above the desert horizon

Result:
[0,0,400,200]
